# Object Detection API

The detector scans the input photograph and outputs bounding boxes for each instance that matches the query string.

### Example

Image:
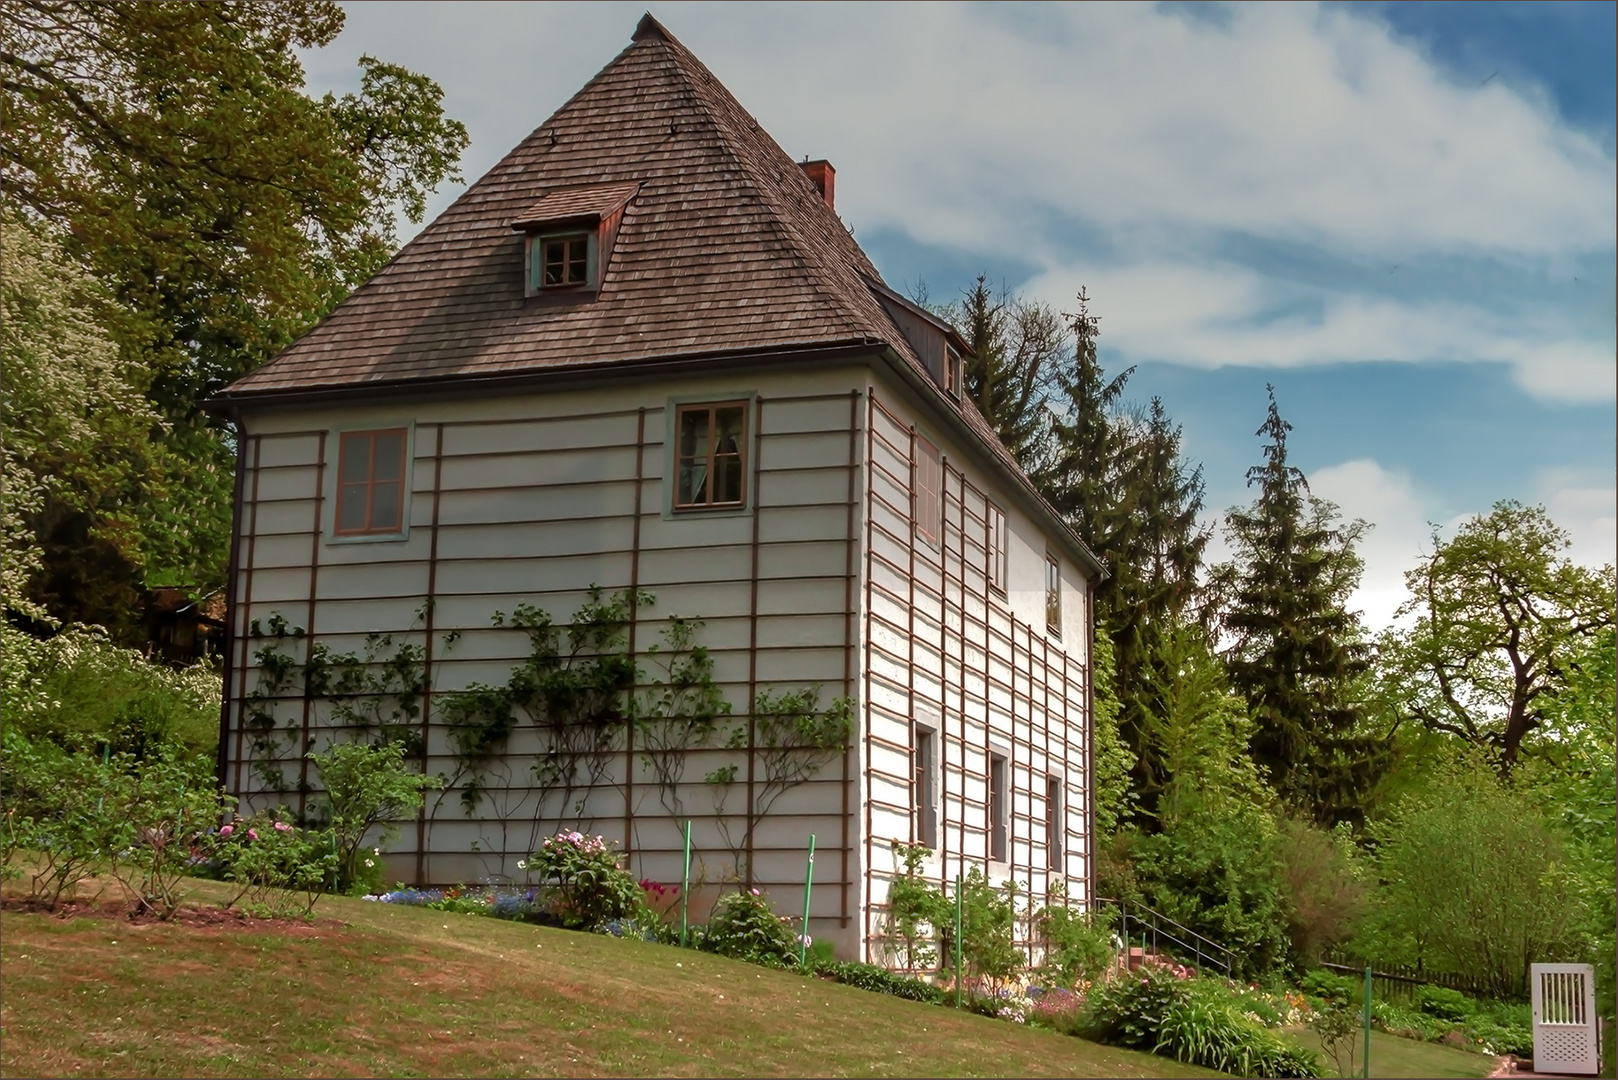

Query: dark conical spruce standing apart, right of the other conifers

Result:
[1215,385,1385,824]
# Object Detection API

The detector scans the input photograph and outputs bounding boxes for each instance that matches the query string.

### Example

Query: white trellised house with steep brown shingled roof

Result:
[212,16,1102,959]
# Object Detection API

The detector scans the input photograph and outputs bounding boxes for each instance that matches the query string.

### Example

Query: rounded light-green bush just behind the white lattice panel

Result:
[1356,758,1584,997]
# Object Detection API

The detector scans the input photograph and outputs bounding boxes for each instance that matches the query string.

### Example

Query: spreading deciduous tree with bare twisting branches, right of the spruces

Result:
[1383,500,1615,773]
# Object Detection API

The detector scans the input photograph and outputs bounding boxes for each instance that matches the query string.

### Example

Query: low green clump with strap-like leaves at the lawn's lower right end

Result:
[1082,967,1322,1077]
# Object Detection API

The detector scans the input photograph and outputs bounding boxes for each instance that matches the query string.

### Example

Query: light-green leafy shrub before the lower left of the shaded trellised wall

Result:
[309,743,443,892]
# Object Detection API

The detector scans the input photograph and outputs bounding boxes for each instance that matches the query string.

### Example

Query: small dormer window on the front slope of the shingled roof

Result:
[511,181,641,300]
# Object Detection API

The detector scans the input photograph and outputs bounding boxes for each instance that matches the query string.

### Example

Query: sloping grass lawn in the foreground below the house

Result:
[0,882,1216,1077]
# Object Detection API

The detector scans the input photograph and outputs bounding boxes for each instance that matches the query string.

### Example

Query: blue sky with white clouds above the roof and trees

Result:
[303,0,1618,628]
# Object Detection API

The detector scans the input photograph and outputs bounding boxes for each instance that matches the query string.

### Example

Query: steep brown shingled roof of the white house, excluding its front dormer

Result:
[222,16,914,402]
